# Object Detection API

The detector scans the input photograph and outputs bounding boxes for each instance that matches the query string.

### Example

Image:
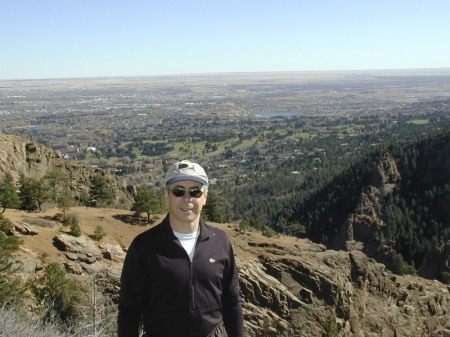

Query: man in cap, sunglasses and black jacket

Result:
[118,160,244,337]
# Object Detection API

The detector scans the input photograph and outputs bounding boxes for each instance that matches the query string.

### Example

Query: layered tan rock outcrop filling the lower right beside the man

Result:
[239,236,450,337]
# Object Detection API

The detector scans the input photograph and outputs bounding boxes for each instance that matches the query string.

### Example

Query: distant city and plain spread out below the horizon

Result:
[0,70,450,188]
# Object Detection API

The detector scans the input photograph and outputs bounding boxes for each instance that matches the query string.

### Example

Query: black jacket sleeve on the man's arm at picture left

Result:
[117,245,147,337]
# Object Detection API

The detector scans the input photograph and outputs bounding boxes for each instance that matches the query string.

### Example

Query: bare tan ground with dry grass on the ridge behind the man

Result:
[4,203,299,262]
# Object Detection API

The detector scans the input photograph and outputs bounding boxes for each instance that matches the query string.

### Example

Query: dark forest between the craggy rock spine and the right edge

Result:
[382,132,450,265]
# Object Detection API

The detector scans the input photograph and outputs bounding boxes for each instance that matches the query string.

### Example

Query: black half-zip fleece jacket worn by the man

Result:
[118,216,244,337]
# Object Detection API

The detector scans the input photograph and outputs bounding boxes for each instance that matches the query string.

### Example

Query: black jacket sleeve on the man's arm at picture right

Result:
[222,244,244,337]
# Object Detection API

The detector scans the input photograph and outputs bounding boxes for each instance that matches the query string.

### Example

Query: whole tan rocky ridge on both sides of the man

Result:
[6,209,450,337]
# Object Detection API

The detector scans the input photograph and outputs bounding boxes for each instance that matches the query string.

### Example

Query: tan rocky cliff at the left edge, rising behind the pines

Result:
[0,135,134,205]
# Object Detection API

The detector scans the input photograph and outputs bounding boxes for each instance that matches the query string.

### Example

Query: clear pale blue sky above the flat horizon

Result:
[0,0,450,79]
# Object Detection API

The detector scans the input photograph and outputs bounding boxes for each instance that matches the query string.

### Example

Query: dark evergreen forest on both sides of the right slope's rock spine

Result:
[291,132,450,247]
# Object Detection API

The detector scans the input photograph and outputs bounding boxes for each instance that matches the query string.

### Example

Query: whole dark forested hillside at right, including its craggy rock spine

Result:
[270,129,450,282]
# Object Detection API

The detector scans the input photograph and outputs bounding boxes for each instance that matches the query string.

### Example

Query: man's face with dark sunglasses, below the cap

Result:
[166,180,207,225]
